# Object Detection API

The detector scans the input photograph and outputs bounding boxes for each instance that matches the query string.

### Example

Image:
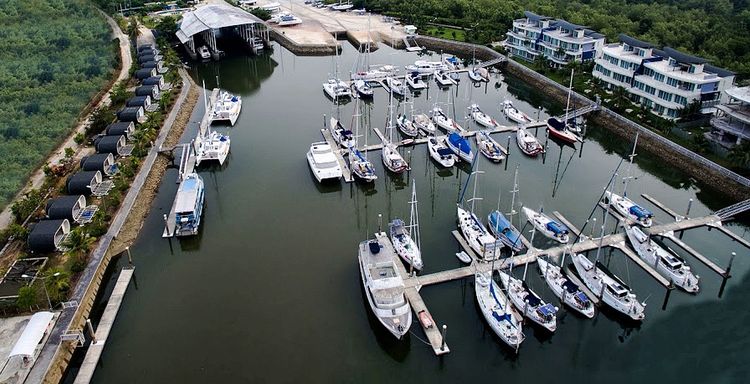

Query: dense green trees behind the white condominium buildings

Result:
[362,0,750,79]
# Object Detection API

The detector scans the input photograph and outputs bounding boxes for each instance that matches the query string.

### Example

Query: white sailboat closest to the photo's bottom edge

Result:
[474,272,525,351]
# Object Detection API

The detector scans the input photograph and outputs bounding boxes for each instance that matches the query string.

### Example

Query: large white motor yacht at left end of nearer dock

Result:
[358,239,412,339]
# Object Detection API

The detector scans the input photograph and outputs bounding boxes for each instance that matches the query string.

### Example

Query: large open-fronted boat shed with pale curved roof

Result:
[175,4,270,60]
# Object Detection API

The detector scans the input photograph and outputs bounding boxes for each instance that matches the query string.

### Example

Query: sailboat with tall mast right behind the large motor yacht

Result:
[388,181,424,271]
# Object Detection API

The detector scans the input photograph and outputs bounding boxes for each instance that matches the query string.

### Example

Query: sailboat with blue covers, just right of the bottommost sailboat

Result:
[499,266,557,332]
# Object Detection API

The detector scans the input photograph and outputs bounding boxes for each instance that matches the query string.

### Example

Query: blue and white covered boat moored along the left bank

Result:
[174,173,204,236]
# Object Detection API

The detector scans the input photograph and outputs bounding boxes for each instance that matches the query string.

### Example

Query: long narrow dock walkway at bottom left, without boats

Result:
[74,268,135,384]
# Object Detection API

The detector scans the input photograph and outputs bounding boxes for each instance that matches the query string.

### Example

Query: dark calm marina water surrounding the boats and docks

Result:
[94,44,750,383]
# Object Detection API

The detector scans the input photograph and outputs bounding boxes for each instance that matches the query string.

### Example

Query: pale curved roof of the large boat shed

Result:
[176,4,263,44]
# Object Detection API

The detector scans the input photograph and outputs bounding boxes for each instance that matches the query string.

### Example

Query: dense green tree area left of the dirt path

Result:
[0,0,117,207]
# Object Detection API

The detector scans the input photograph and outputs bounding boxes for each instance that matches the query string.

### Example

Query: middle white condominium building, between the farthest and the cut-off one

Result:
[593,35,734,119]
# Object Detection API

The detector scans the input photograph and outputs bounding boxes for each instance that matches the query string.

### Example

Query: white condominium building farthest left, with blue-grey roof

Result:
[503,11,604,66]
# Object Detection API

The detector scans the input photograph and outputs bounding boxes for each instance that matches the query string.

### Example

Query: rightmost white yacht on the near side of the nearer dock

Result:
[625,225,700,293]
